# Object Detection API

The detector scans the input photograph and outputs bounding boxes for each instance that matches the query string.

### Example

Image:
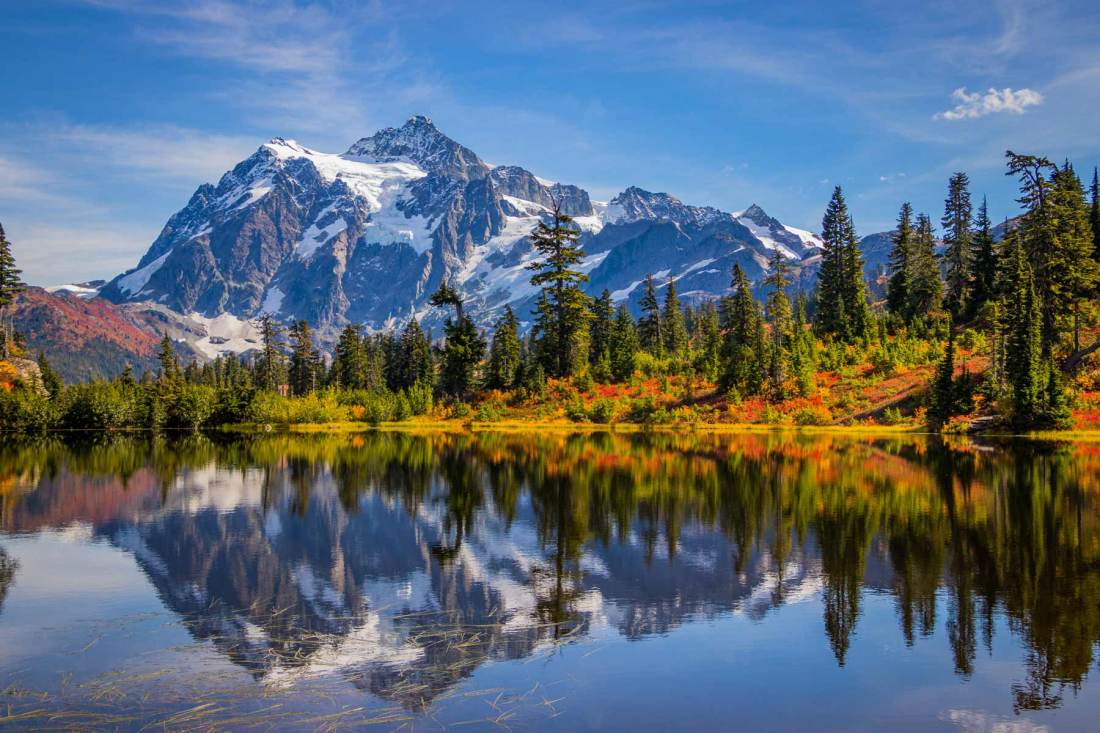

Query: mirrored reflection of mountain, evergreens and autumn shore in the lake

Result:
[0,434,1100,711]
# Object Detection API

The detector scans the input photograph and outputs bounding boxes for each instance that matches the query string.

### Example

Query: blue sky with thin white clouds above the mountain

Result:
[0,0,1100,284]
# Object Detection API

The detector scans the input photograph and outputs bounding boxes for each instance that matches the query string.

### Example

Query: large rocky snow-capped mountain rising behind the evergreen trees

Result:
[99,117,821,349]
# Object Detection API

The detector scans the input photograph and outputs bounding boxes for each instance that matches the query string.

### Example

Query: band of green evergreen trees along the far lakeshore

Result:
[0,151,1100,429]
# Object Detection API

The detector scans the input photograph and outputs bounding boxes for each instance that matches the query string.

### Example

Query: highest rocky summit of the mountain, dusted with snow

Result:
[344,116,490,180]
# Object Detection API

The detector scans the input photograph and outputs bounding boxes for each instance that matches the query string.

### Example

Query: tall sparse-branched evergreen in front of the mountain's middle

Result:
[528,205,592,376]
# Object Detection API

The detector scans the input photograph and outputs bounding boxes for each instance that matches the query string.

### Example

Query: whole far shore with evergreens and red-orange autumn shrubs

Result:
[0,152,1100,431]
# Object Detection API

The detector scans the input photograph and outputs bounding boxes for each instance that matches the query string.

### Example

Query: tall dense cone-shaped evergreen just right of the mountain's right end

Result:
[815,186,871,341]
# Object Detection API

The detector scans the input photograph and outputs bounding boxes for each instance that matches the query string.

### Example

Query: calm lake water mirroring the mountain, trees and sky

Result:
[0,433,1100,733]
